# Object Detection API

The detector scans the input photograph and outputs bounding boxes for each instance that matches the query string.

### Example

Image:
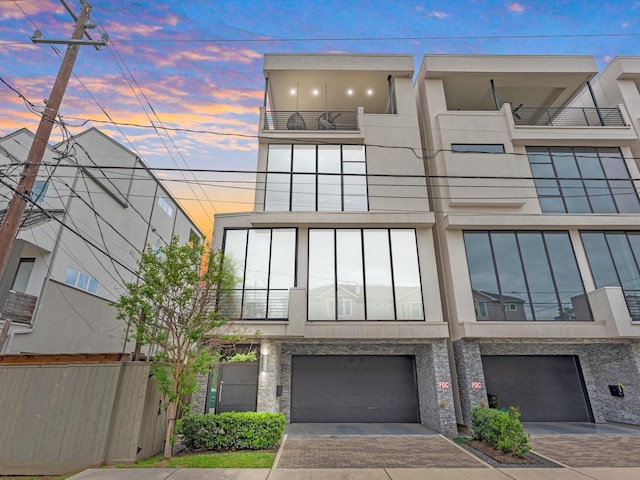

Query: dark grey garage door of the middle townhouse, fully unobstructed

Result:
[291,355,419,423]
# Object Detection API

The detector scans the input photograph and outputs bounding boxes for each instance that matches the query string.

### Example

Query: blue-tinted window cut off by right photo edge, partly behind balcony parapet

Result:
[582,232,640,321]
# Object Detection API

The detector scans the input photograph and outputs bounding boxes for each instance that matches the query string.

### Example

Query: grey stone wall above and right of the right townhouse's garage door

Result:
[480,340,640,425]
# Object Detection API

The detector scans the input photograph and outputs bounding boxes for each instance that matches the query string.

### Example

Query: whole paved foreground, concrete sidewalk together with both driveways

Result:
[70,424,640,480]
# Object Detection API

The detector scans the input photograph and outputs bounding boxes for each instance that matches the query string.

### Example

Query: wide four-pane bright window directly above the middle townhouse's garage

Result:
[308,229,424,321]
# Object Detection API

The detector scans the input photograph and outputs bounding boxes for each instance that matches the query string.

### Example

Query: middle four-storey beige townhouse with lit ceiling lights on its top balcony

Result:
[209,54,456,435]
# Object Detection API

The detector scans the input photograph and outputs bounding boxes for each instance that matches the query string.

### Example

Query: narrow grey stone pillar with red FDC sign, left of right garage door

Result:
[453,340,487,427]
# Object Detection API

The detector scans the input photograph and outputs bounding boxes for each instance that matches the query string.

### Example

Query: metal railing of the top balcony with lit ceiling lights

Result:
[263,110,358,132]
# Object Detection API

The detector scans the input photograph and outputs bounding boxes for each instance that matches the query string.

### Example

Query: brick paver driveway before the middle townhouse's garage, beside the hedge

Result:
[278,435,486,468]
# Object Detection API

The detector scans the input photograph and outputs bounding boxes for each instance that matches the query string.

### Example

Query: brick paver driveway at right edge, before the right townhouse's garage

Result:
[531,435,640,468]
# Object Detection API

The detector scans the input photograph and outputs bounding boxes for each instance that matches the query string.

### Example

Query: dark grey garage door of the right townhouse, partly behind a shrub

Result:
[482,355,593,422]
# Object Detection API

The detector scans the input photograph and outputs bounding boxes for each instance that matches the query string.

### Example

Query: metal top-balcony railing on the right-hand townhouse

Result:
[511,105,627,127]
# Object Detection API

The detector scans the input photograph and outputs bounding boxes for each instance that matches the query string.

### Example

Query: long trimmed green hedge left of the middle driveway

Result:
[180,412,285,451]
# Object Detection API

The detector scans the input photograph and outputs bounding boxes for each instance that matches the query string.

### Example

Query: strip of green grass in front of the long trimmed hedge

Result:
[115,452,276,468]
